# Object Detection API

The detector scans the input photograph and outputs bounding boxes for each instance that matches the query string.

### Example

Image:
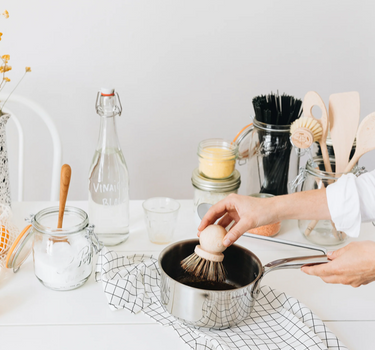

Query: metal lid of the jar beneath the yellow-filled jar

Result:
[191,168,241,193]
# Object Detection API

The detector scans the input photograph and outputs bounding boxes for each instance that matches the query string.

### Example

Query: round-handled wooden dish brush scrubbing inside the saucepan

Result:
[181,225,227,282]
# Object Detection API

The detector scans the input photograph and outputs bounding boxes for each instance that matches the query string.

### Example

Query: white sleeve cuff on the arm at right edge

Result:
[327,170,375,237]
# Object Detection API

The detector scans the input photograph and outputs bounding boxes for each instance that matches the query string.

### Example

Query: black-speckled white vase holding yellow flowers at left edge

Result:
[0,111,11,206]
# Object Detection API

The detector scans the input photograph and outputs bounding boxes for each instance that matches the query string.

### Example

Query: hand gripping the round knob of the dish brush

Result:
[198,194,278,247]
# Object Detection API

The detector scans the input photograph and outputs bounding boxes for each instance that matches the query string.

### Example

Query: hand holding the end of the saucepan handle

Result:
[302,241,375,288]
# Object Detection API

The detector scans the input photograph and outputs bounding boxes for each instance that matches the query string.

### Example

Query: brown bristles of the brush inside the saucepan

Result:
[181,253,226,282]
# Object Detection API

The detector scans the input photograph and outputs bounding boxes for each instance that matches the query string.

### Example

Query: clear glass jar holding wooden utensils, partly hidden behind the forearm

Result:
[296,157,355,246]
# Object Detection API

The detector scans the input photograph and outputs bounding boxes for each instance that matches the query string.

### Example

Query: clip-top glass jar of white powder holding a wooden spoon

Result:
[31,207,99,290]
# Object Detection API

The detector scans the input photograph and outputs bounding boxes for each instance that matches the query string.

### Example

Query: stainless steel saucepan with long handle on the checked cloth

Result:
[159,234,328,329]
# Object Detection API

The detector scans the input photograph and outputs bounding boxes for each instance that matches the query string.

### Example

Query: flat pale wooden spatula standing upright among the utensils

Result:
[329,91,360,174]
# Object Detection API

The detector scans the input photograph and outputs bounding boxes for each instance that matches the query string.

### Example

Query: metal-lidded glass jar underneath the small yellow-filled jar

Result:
[191,168,241,224]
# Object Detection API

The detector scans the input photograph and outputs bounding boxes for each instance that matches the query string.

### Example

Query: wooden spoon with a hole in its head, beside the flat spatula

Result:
[302,91,332,172]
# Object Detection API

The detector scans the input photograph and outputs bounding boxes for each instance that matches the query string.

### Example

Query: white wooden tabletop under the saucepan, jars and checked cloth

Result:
[0,200,375,350]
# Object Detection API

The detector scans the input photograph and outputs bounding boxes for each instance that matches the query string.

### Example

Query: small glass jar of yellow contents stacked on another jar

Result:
[198,139,238,180]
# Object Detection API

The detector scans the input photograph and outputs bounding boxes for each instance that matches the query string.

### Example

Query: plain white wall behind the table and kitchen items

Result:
[0,0,375,200]
